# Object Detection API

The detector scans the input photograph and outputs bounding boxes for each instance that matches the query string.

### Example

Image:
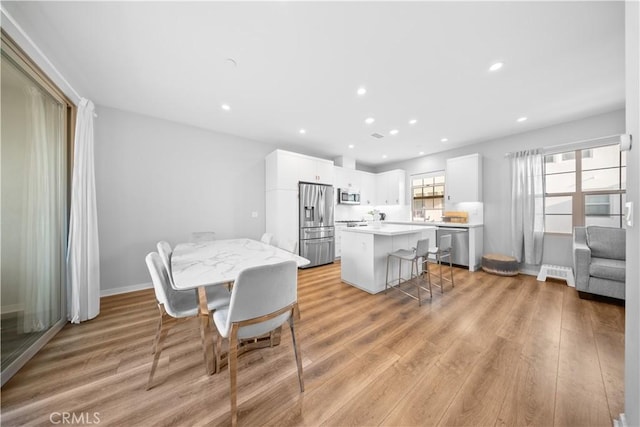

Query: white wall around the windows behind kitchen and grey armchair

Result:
[378,110,625,273]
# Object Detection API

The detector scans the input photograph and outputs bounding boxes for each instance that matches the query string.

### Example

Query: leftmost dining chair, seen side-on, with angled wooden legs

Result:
[145,252,231,390]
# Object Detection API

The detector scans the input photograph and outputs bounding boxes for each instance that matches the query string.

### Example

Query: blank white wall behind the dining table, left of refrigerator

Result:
[95,106,275,295]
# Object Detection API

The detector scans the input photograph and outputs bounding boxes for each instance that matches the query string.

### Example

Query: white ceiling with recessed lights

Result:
[3,1,624,166]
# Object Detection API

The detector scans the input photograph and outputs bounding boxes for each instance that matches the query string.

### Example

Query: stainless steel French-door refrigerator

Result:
[299,182,335,267]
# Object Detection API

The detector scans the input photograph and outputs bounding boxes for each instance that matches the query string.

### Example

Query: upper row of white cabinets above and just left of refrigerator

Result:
[265,150,333,191]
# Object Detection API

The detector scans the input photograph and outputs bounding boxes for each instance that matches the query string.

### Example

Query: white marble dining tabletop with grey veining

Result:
[171,239,310,289]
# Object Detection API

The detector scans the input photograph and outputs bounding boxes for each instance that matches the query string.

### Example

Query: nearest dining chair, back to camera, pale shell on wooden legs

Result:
[213,261,304,426]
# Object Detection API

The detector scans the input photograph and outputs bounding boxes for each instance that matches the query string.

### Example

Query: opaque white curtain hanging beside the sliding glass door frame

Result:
[67,98,100,323]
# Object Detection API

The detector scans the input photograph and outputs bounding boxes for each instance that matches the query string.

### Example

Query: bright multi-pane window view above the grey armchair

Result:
[544,145,627,234]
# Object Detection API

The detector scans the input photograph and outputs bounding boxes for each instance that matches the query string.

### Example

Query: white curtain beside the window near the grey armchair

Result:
[510,150,544,265]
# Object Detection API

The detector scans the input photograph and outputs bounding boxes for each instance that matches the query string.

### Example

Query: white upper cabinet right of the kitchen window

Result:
[445,153,482,205]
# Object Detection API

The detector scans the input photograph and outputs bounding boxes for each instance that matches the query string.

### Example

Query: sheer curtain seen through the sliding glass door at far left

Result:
[20,87,65,332]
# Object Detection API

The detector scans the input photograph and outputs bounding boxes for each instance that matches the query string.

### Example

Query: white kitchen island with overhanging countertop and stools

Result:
[340,224,436,294]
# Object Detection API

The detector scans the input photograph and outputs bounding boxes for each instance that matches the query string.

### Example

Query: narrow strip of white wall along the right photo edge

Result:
[624,1,640,426]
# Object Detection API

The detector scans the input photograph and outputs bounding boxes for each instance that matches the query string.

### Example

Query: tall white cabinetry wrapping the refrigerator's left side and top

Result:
[265,150,334,251]
